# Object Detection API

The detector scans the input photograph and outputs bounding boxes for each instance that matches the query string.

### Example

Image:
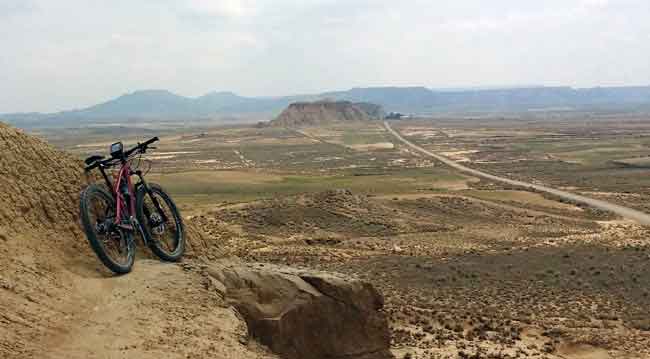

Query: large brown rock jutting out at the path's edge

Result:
[207,262,392,359]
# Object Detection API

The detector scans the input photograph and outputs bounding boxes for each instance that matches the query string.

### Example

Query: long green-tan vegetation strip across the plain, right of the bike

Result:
[150,168,466,204]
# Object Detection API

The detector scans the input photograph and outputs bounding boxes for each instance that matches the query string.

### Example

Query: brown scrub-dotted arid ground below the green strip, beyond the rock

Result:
[194,191,650,358]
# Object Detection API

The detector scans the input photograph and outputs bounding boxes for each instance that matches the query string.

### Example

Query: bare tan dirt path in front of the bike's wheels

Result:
[39,260,274,359]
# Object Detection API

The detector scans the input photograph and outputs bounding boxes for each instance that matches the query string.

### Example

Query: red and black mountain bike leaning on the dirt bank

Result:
[79,137,185,274]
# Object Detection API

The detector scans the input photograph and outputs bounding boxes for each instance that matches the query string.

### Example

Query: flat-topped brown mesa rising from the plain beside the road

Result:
[270,101,384,127]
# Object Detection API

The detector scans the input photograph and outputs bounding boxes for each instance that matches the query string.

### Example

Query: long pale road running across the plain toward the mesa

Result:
[384,121,650,225]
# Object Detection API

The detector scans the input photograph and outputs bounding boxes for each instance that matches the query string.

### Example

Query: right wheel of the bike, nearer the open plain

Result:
[136,183,185,262]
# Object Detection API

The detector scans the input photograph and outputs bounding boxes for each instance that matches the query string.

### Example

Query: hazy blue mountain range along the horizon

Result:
[0,86,650,127]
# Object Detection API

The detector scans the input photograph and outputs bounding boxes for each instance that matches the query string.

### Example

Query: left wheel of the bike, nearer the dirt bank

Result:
[80,184,135,274]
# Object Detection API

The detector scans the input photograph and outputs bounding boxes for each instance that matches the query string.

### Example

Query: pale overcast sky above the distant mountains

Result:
[0,0,650,113]
